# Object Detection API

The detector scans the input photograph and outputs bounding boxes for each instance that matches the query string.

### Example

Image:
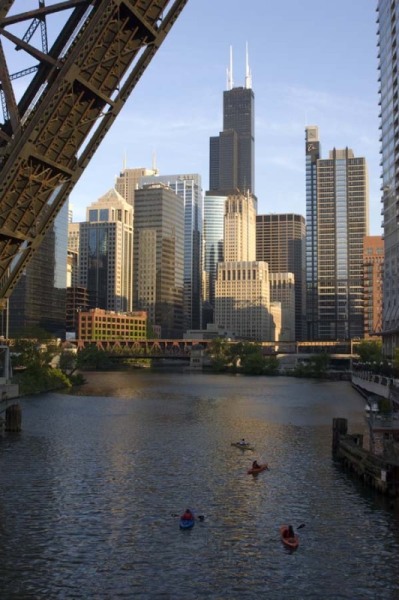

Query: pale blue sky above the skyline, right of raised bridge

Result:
[5,0,382,235]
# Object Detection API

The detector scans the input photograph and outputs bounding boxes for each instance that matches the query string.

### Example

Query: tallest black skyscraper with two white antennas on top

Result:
[209,49,255,195]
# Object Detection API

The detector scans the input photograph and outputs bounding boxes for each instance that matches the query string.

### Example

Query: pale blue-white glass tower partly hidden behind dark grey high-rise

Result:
[139,174,203,331]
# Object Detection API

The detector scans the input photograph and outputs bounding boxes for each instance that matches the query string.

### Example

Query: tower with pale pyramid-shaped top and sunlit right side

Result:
[79,189,133,311]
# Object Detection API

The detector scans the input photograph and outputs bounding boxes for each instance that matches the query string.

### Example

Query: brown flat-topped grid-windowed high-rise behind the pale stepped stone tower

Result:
[256,214,306,341]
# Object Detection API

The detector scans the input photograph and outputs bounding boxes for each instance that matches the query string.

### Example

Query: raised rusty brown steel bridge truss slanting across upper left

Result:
[0,0,187,308]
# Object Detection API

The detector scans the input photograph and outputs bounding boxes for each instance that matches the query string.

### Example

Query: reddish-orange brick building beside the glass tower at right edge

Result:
[363,235,384,337]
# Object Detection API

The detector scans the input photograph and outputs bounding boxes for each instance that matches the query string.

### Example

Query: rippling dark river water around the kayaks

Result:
[0,370,399,600]
